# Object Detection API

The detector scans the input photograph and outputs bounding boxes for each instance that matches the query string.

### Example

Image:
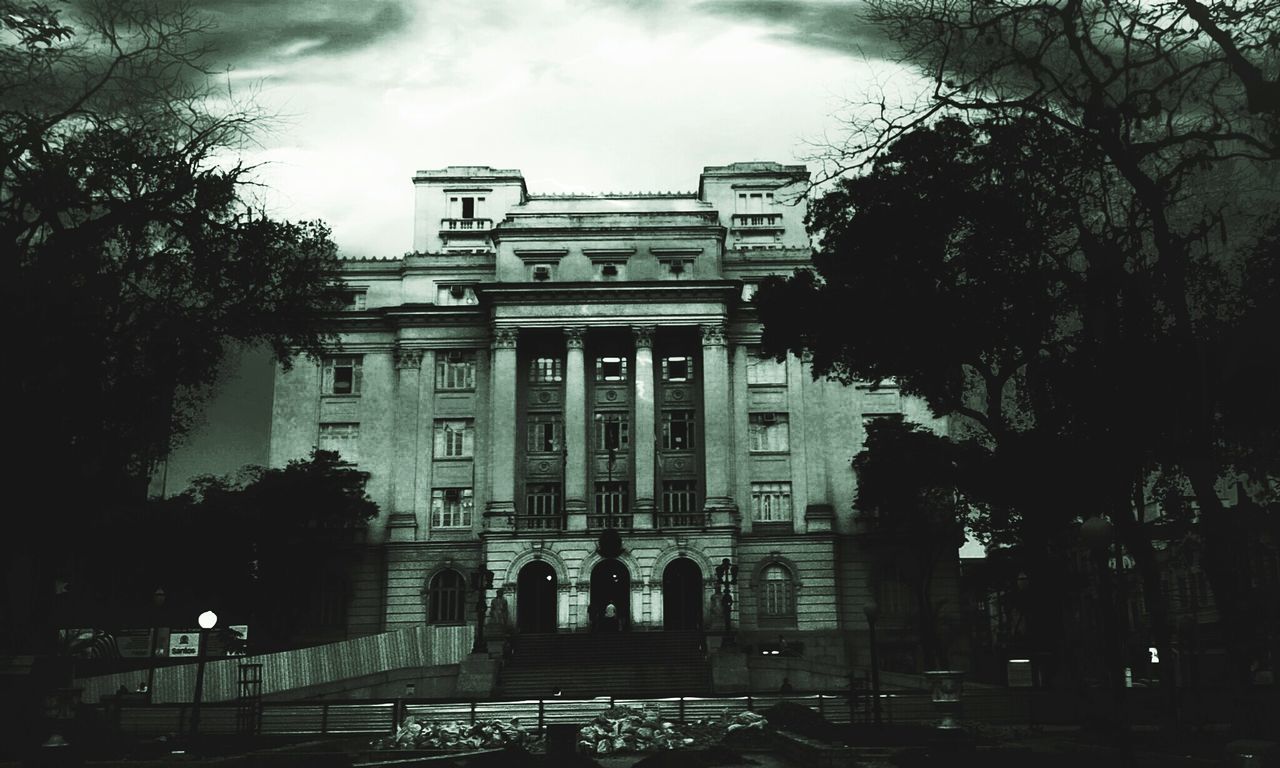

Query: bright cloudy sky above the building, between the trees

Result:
[170,0,911,256]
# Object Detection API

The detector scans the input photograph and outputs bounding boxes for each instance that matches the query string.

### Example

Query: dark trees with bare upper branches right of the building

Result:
[755,0,1280,737]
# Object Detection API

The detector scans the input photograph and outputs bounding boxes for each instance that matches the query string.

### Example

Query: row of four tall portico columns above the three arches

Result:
[485,324,735,530]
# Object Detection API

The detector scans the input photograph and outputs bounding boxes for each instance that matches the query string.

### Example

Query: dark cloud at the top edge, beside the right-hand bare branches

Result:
[696,0,897,59]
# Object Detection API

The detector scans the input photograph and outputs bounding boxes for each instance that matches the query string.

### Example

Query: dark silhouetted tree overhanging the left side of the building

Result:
[0,0,342,650]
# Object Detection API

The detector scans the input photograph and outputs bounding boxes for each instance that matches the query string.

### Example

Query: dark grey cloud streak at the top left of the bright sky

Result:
[76,0,412,69]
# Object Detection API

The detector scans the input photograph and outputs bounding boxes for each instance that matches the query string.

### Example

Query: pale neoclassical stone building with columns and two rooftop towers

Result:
[270,163,945,664]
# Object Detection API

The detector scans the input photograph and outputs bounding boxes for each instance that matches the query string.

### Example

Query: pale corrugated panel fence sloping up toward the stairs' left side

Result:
[76,626,475,706]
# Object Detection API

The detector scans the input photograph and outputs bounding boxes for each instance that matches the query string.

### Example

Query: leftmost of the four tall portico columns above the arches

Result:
[485,321,520,531]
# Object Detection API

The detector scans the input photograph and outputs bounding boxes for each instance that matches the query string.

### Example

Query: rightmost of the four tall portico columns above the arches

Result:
[701,323,737,526]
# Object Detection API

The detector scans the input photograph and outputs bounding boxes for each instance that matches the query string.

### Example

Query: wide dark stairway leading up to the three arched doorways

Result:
[497,632,712,699]
